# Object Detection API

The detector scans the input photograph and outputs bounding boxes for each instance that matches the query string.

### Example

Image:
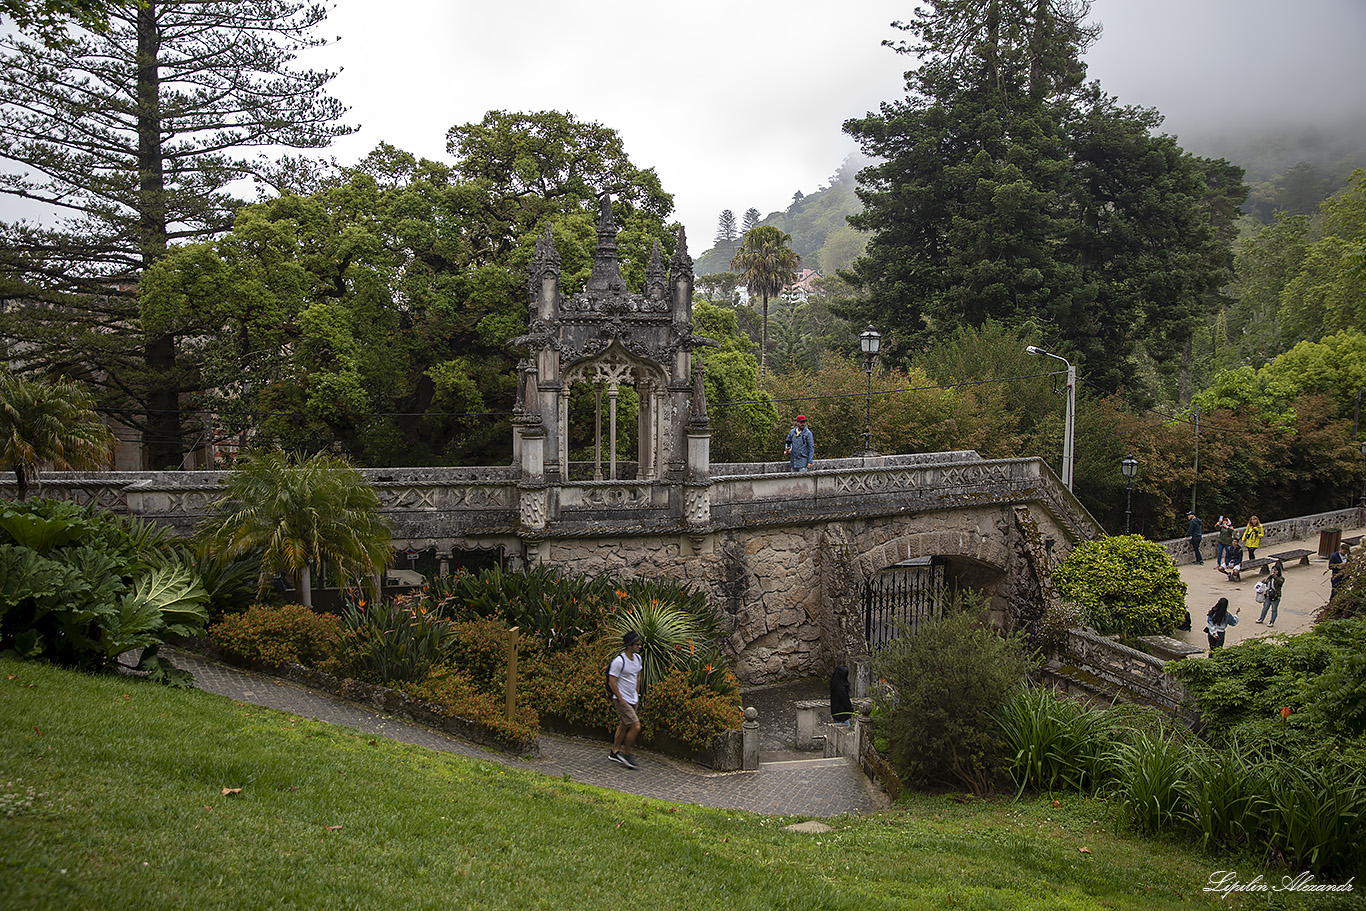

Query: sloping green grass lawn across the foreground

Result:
[0,660,1349,911]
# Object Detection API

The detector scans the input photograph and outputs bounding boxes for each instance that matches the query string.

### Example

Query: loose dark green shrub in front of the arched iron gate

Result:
[874,601,1034,794]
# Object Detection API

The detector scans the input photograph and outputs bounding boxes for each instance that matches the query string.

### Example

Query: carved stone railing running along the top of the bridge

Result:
[0,452,1100,548]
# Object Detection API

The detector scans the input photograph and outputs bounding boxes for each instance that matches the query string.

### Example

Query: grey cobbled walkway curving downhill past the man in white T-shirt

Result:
[164,649,887,817]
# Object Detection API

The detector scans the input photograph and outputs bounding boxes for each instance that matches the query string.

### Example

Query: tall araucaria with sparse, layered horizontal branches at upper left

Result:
[0,0,348,468]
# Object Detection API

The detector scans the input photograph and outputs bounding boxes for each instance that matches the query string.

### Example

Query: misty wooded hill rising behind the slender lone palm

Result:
[694,156,866,276]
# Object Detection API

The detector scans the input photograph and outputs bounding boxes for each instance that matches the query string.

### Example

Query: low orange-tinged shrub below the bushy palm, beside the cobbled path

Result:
[209,604,344,668]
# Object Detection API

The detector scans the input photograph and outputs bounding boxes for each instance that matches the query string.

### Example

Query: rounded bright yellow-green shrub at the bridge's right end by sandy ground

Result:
[1053,534,1186,636]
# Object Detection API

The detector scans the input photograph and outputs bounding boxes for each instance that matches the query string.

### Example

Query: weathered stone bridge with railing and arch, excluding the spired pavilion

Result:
[0,452,1100,683]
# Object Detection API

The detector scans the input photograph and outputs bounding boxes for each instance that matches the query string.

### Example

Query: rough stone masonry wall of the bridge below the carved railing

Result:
[546,507,1065,684]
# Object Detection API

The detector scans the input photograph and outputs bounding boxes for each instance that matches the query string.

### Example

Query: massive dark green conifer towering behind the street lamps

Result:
[844,0,1246,392]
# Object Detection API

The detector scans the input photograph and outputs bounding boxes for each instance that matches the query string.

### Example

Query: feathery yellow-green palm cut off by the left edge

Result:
[0,369,113,500]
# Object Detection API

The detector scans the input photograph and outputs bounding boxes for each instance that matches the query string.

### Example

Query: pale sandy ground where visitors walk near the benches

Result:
[1175,529,1366,649]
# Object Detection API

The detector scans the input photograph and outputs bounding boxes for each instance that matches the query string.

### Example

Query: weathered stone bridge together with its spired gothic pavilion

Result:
[0,198,1100,683]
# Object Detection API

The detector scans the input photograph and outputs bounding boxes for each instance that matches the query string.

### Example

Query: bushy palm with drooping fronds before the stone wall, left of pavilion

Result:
[199,449,393,606]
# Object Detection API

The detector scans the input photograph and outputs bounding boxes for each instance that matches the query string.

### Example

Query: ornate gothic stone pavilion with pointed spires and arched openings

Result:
[511,197,716,556]
